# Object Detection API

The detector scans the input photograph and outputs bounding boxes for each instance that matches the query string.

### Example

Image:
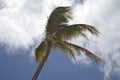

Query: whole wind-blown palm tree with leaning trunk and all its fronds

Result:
[32,6,101,80]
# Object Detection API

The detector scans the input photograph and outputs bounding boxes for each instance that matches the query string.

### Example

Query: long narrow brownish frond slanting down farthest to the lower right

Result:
[64,41,102,64]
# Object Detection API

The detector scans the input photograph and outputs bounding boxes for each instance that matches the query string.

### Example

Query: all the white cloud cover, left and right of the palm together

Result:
[0,0,120,79]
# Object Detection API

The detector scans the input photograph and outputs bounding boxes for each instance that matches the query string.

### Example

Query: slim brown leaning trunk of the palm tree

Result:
[32,42,51,80]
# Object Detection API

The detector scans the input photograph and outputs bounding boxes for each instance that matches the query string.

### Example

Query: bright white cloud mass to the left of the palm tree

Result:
[0,0,46,49]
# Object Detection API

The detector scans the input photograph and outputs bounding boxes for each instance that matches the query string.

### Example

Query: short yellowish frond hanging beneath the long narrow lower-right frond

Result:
[56,42,76,61]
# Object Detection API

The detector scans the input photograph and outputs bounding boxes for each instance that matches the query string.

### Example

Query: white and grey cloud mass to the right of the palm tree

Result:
[71,0,120,79]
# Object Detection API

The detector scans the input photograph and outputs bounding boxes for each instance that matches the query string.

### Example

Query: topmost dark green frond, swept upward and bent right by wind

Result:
[46,7,72,33]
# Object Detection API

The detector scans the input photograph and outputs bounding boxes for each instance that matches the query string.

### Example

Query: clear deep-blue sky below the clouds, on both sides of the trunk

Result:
[0,46,103,80]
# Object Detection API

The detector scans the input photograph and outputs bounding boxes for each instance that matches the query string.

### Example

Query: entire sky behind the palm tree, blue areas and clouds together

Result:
[0,0,120,80]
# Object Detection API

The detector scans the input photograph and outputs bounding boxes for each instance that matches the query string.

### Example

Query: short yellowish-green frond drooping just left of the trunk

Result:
[35,41,47,62]
